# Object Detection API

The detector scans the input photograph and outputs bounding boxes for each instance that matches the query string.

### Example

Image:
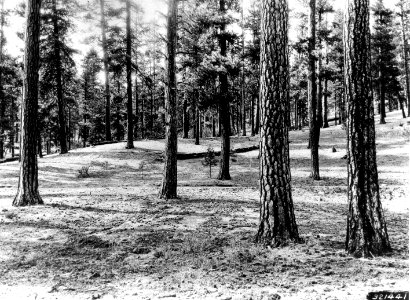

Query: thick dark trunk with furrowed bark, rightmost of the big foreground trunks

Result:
[345,0,391,257]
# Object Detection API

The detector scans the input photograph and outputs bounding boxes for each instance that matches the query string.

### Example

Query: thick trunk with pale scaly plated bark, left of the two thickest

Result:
[256,0,300,247]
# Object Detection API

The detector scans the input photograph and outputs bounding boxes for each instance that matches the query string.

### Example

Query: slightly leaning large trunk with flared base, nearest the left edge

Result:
[13,0,43,206]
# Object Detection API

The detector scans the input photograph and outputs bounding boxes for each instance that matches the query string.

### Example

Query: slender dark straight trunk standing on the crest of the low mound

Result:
[126,0,134,149]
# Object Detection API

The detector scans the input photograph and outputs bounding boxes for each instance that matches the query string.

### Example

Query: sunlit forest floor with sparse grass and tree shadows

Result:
[0,112,410,300]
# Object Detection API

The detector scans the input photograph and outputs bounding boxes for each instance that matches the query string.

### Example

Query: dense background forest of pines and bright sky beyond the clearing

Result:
[0,0,409,155]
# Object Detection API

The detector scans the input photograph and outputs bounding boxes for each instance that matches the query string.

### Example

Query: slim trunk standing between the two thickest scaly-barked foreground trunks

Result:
[308,0,320,180]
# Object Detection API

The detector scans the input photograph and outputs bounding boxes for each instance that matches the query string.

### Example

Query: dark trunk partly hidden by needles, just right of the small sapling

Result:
[218,0,231,180]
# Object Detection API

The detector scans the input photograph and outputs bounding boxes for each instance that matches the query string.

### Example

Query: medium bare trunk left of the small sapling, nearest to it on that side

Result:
[160,0,178,199]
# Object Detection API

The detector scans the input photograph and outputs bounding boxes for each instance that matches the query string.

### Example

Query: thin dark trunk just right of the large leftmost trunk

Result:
[52,0,68,154]
